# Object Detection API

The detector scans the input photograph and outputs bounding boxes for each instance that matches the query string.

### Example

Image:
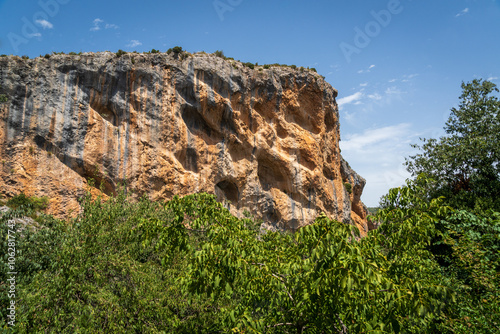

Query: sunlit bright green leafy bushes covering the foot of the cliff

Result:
[0,184,474,333]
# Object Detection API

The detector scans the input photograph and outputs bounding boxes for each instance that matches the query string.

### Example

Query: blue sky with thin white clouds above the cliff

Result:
[0,0,500,206]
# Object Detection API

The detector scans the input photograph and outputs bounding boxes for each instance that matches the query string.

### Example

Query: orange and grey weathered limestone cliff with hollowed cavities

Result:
[0,52,367,234]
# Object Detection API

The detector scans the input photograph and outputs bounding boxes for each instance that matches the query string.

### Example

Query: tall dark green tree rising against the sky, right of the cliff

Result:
[406,79,500,211]
